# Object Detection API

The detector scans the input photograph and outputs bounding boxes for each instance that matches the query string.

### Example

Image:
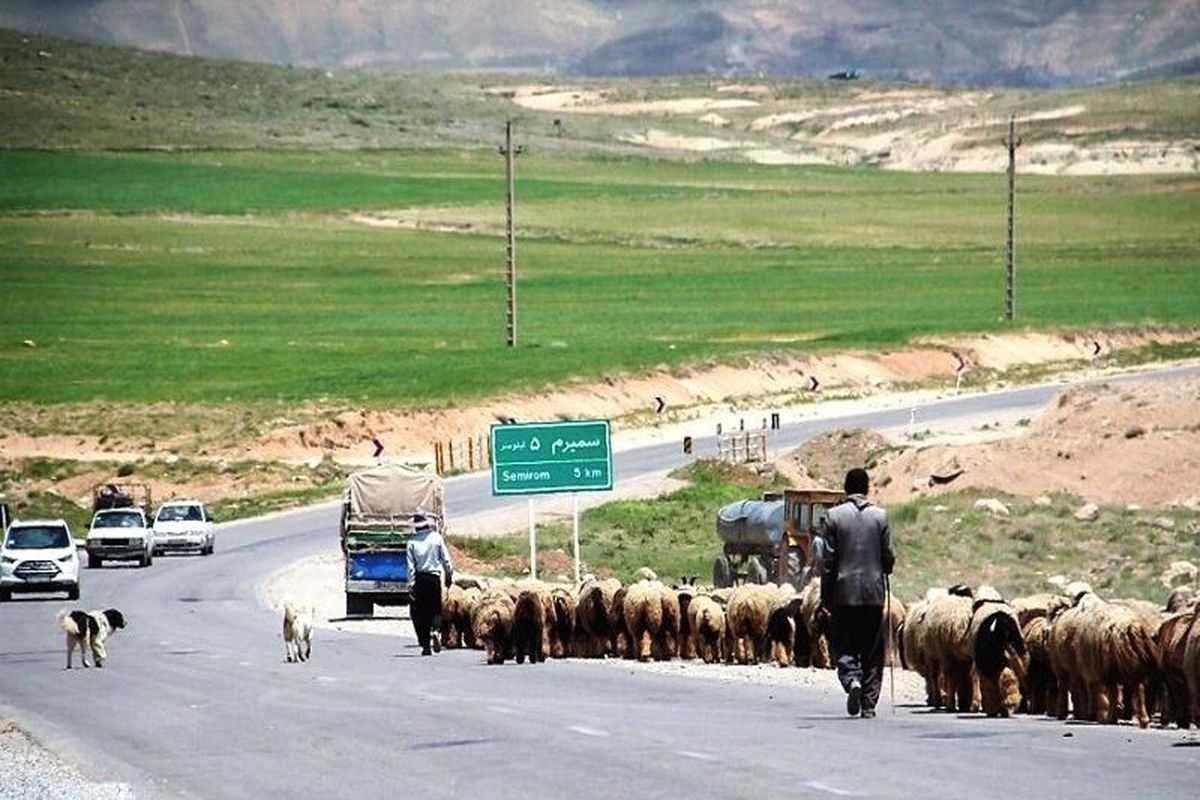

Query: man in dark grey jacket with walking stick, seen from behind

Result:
[821,468,896,718]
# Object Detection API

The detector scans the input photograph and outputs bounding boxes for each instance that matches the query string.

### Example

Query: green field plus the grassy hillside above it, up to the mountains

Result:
[0,26,1200,412]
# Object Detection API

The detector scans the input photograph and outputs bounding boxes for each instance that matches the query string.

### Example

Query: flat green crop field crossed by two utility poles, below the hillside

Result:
[0,151,1200,405]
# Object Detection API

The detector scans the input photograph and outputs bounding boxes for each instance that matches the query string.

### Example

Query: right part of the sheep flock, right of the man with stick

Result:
[899,582,1200,728]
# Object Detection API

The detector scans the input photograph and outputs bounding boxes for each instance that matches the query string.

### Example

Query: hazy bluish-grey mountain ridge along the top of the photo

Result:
[9,0,1200,86]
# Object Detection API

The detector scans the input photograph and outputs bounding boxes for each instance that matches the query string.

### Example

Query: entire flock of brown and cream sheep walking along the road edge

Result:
[442,569,1200,728]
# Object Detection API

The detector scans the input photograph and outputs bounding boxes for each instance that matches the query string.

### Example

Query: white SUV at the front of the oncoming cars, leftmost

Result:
[0,519,79,601]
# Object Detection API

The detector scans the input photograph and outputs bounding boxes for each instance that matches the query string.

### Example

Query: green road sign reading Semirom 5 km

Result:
[492,420,612,494]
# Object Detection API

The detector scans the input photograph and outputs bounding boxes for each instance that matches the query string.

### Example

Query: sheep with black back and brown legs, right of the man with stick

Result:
[968,587,1027,717]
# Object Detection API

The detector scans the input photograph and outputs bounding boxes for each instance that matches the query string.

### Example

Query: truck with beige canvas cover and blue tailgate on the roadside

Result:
[341,463,445,616]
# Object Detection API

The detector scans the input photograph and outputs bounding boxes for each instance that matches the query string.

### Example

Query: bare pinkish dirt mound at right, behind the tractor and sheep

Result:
[780,381,1200,509]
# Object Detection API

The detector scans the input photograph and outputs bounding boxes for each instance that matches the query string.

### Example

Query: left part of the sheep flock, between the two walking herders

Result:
[442,569,904,667]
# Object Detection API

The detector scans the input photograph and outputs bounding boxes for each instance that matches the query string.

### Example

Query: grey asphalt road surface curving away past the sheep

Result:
[0,367,1200,800]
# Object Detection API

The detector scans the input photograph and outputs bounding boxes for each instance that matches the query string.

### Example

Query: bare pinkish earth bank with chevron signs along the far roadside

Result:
[230,330,1200,461]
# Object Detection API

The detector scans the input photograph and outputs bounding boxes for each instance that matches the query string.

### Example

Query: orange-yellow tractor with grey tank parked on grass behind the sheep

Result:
[713,489,845,590]
